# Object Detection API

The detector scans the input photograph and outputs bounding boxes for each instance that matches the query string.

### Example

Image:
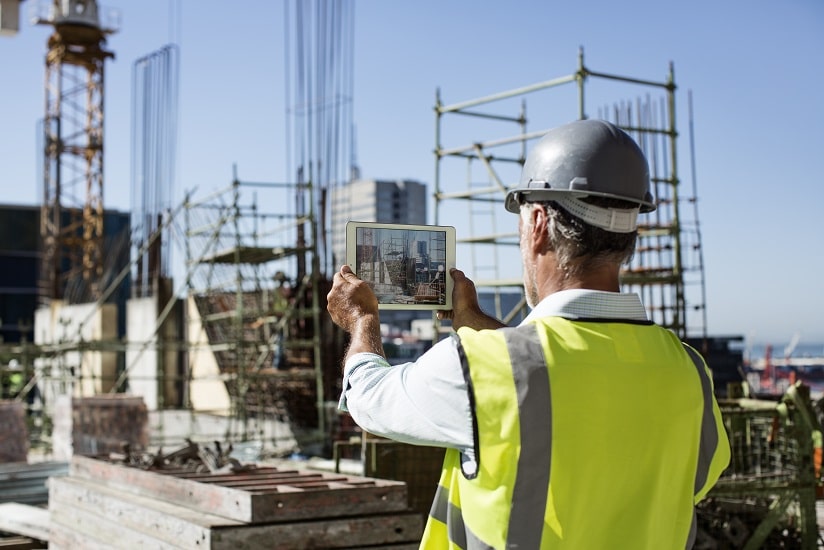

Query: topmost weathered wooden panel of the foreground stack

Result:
[71,455,408,523]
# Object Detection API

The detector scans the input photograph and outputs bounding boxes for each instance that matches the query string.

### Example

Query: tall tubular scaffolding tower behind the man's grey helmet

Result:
[433,50,706,338]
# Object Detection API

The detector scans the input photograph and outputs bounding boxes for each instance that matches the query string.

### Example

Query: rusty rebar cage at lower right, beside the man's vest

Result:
[695,383,821,549]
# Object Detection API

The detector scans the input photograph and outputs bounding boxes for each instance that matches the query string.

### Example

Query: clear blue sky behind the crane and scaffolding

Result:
[0,0,824,344]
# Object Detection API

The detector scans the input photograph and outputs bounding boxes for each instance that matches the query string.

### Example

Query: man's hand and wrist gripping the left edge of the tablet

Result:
[326,265,385,358]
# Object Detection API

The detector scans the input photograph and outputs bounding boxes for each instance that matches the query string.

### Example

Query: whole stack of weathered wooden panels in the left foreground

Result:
[49,455,423,550]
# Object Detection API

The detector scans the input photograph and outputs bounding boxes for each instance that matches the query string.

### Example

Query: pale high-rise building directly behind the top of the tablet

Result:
[332,179,426,266]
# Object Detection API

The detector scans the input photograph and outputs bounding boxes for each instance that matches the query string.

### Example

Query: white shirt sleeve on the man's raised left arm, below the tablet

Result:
[338,338,473,452]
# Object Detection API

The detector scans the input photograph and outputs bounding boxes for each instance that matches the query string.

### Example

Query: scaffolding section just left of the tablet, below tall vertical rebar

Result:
[184,170,342,450]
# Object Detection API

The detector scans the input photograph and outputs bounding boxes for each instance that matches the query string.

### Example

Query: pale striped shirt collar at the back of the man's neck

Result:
[521,288,649,324]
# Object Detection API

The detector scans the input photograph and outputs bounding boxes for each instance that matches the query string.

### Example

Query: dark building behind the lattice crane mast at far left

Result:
[0,204,131,343]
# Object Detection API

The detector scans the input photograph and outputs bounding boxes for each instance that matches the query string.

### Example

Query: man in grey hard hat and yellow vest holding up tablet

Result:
[328,120,729,550]
